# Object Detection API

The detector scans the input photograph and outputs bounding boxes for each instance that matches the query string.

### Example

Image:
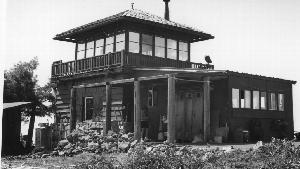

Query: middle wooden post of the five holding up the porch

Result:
[134,81,141,140]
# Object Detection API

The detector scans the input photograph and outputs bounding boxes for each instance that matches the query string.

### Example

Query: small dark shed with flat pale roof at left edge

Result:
[1,102,30,156]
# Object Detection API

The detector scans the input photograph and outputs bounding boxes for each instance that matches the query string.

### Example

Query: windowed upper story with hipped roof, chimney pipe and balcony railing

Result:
[52,3,214,79]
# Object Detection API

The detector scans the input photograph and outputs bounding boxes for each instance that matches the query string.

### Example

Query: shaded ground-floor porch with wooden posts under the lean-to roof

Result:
[70,73,210,143]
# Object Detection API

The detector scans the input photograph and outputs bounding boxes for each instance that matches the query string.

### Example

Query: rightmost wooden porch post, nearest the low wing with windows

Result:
[203,77,210,142]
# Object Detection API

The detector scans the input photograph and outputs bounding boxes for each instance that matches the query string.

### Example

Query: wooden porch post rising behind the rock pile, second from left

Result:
[104,83,111,134]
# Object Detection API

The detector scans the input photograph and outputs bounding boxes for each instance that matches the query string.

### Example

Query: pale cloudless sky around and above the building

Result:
[0,0,300,130]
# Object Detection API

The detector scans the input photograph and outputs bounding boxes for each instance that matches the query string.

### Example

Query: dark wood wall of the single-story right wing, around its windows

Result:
[227,75,294,142]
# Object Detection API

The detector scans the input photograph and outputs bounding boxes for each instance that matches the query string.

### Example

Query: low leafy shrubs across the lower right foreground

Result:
[126,139,300,169]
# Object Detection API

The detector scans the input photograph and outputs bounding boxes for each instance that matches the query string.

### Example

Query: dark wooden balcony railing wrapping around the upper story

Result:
[52,51,214,77]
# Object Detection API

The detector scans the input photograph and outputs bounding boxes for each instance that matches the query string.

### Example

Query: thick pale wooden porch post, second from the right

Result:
[168,75,176,143]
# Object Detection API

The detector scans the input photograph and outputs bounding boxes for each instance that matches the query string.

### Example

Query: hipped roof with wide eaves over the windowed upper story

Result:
[54,9,214,40]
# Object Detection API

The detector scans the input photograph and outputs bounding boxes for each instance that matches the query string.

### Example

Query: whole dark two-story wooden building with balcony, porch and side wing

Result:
[52,0,295,142]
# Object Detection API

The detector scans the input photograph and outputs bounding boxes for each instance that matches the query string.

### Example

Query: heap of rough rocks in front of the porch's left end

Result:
[51,129,136,156]
